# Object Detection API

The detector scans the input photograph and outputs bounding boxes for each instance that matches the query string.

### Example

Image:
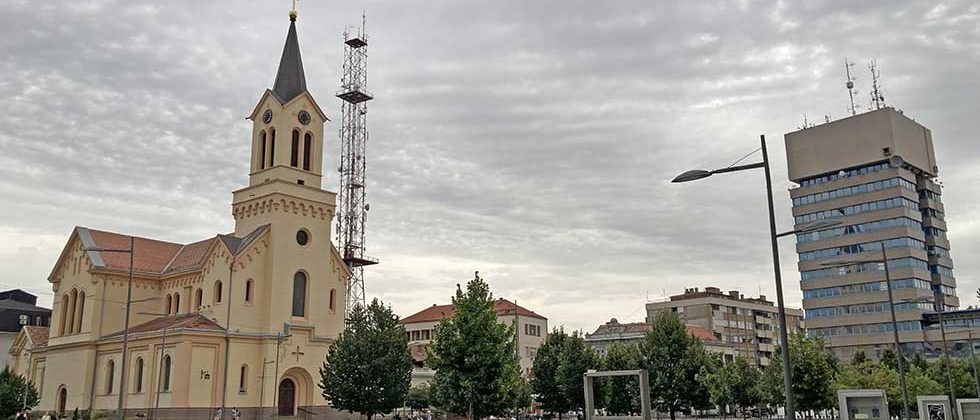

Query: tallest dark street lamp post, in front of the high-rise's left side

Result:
[671,135,840,420]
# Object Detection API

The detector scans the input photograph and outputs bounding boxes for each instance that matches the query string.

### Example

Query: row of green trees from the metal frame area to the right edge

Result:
[531,312,980,418]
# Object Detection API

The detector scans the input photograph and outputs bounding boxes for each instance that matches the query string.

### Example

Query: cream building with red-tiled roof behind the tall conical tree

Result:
[401,299,548,384]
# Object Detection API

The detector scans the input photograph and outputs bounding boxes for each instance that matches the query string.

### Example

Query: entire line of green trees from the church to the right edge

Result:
[320,275,978,419]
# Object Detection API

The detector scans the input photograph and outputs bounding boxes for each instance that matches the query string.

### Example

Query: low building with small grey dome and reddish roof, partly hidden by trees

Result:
[585,318,735,361]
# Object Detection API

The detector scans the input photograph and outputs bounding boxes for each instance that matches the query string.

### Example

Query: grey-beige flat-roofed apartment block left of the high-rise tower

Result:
[646,287,804,366]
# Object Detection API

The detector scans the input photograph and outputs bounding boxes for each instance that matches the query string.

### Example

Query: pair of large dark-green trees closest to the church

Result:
[319,273,532,419]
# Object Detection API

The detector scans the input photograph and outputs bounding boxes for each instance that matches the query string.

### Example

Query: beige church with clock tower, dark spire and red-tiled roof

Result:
[10,14,358,419]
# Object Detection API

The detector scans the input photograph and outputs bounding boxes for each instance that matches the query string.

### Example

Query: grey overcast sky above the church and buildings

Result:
[0,0,980,331]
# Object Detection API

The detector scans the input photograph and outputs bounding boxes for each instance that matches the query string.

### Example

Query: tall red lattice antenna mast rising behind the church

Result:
[337,15,378,314]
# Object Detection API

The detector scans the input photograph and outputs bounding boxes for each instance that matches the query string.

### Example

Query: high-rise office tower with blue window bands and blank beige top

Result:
[785,108,959,359]
